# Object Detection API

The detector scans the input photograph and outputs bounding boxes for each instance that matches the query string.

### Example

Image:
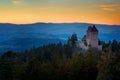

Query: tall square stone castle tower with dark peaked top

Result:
[86,26,98,48]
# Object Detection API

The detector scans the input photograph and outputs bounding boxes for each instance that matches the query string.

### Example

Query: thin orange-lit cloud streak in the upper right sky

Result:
[99,4,120,11]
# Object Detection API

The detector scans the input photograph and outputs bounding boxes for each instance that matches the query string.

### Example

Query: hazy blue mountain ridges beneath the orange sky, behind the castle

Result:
[0,23,120,52]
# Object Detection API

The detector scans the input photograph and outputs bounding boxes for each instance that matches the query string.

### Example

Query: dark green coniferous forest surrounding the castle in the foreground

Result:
[0,34,120,80]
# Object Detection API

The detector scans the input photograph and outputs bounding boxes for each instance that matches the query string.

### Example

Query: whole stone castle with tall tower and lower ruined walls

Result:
[76,26,102,50]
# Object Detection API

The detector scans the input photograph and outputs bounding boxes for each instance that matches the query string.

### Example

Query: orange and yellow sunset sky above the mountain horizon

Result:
[0,0,120,25]
